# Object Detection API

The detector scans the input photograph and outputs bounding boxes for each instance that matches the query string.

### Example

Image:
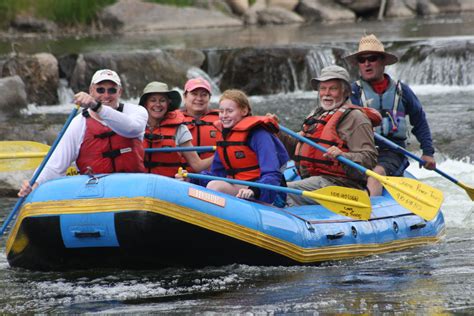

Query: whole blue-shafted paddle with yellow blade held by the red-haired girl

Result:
[179,168,372,220]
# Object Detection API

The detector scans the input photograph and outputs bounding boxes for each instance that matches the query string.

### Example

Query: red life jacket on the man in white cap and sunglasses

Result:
[76,104,145,174]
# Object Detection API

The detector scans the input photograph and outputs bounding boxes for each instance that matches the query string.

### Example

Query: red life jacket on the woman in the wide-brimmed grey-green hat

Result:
[143,111,184,178]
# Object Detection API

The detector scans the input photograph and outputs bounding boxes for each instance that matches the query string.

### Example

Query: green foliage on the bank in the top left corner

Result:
[0,0,116,26]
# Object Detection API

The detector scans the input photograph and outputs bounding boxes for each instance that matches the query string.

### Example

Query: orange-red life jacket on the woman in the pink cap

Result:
[182,110,220,159]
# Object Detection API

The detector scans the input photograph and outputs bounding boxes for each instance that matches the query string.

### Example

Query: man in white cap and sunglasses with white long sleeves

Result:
[18,69,148,196]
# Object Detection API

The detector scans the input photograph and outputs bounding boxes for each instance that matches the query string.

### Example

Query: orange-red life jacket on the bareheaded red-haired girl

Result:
[214,116,278,181]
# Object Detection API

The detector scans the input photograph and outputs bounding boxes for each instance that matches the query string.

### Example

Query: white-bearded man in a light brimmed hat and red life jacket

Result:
[280,65,380,206]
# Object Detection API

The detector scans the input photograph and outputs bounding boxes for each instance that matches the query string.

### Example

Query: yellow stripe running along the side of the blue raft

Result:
[6,197,444,263]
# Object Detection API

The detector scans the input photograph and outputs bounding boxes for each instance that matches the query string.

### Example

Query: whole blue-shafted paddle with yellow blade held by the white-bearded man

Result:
[280,125,443,220]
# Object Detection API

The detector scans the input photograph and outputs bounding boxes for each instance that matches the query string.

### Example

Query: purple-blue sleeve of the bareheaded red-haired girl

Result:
[249,128,290,203]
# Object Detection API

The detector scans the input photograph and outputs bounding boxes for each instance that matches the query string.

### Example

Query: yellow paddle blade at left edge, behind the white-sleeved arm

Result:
[0,141,49,172]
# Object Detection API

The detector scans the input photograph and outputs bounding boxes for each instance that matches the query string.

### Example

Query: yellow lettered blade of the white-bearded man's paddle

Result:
[370,172,443,221]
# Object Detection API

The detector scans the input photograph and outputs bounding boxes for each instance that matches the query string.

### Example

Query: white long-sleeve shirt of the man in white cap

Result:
[36,103,148,184]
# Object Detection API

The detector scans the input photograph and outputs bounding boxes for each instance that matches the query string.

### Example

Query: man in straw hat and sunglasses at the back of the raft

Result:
[345,34,436,196]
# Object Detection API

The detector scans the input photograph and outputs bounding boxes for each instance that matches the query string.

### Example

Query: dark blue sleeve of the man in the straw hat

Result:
[402,83,434,156]
